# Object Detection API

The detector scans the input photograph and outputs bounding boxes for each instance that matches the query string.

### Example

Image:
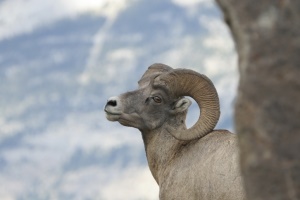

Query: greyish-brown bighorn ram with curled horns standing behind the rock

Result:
[105,64,245,200]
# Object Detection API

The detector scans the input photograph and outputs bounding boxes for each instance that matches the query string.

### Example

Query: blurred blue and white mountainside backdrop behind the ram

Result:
[0,0,238,200]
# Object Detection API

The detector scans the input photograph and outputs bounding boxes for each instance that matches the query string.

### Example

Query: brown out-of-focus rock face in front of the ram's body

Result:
[217,0,300,200]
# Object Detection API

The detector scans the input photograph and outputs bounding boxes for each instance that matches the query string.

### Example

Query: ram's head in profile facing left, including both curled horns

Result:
[105,64,220,140]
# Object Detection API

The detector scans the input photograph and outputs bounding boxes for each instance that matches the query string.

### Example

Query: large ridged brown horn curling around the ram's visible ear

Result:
[155,69,220,140]
